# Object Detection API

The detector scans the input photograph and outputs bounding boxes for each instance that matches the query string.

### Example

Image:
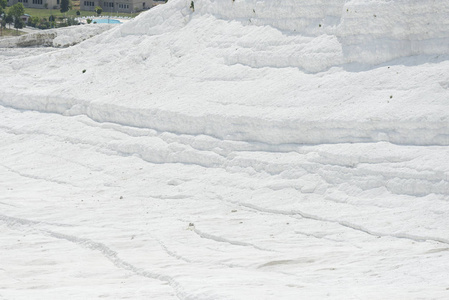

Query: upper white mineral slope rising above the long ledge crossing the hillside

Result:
[0,0,449,145]
